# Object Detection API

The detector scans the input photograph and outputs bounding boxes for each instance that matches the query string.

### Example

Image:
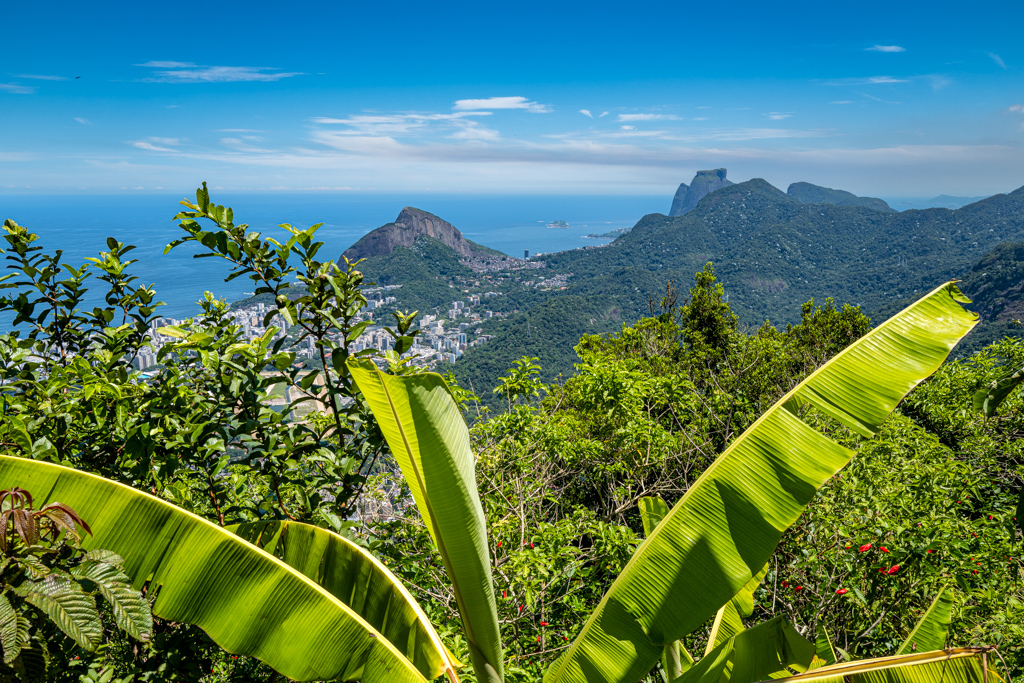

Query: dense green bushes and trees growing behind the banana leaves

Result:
[0,188,1024,681]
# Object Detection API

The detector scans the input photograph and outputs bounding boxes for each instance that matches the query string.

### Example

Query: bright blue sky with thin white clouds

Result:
[0,0,1024,197]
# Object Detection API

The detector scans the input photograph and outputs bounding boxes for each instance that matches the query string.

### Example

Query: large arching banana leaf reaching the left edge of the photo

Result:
[0,456,433,683]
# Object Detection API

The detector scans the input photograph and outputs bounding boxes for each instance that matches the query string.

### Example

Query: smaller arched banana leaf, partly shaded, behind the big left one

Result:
[227,521,461,681]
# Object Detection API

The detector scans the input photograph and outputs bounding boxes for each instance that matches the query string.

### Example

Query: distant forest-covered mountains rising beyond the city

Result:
[346,174,1024,390]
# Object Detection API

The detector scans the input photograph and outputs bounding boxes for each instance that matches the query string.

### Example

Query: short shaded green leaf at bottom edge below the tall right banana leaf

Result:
[673,616,814,683]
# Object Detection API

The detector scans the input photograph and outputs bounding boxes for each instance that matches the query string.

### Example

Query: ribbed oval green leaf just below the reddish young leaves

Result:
[14,573,103,651]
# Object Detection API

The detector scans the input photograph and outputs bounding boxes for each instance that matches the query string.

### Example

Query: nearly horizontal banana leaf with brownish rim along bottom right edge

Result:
[763,647,1002,683]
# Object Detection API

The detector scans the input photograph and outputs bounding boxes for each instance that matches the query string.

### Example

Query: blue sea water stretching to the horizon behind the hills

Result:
[0,193,671,330]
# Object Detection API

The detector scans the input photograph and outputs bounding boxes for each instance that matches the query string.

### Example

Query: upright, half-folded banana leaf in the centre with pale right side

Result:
[348,362,504,683]
